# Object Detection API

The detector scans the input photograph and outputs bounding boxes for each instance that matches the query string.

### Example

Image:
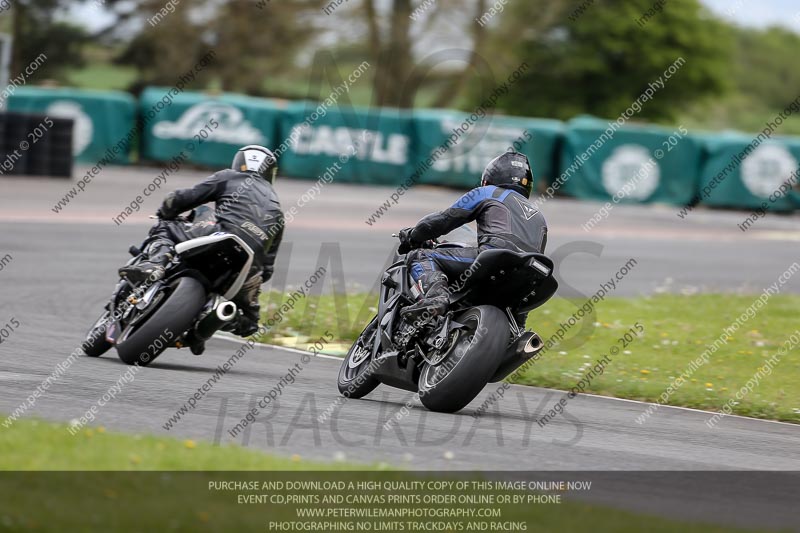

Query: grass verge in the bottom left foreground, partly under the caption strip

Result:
[0,420,756,533]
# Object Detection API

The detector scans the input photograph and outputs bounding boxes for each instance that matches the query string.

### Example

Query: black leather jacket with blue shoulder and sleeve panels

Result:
[411,185,547,253]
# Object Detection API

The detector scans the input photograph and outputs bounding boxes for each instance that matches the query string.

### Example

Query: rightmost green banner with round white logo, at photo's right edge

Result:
[698,133,800,211]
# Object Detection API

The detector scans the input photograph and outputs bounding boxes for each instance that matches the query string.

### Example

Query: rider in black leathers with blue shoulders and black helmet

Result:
[398,151,547,328]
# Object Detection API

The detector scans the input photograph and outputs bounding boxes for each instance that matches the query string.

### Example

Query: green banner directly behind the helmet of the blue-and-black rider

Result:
[414,109,564,187]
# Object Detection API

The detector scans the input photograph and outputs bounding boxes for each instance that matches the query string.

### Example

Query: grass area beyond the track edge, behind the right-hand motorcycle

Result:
[261,293,800,422]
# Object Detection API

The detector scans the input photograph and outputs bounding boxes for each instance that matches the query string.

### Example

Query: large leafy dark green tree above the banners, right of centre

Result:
[484,0,731,120]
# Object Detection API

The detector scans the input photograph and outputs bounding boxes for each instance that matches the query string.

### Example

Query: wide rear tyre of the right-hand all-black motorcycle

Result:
[418,305,509,413]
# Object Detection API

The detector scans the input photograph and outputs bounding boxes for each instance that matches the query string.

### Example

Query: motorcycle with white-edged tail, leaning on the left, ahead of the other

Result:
[82,206,254,366]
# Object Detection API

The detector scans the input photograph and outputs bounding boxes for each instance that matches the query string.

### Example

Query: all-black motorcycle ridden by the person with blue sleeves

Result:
[338,230,558,413]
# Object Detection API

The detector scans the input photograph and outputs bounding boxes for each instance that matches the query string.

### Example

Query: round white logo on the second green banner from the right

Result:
[602,144,661,200]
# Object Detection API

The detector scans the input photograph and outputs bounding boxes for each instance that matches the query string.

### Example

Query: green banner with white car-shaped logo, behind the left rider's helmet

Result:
[139,87,287,168]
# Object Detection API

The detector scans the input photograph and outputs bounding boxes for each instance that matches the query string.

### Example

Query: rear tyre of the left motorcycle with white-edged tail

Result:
[117,277,206,366]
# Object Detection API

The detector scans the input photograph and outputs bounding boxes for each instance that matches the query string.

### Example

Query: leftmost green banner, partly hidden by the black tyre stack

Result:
[8,87,136,164]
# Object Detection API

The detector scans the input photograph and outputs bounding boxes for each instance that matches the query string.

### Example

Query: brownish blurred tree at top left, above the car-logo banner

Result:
[110,0,322,95]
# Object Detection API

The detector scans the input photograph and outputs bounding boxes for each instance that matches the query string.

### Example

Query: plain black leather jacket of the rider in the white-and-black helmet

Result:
[161,169,284,281]
